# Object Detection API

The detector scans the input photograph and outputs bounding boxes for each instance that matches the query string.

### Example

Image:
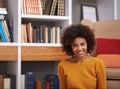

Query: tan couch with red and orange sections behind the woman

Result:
[81,19,120,89]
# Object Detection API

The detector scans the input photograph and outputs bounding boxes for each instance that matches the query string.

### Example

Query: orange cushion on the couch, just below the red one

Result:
[98,54,120,68]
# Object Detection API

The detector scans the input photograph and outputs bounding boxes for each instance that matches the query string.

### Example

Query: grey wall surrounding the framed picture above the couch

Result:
[72,0,120,24]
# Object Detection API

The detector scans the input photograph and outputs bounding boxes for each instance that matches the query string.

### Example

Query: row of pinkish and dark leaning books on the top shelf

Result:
[21,0,65,16]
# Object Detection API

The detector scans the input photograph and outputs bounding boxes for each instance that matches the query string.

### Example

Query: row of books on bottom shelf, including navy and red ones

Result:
[21,72,60,89]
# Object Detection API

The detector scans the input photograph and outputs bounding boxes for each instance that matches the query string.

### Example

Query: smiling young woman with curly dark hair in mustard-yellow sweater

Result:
[58,24,106,89]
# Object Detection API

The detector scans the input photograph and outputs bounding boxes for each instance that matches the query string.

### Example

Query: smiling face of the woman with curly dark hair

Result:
[71,37,87,58]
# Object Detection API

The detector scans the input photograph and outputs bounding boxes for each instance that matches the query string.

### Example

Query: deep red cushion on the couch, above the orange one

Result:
[97,38,120,54]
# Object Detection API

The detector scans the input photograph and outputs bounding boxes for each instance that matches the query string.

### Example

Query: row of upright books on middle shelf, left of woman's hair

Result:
[21,23,63,43]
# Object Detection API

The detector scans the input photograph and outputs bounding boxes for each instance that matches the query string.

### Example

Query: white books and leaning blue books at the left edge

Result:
[0,7,13,42]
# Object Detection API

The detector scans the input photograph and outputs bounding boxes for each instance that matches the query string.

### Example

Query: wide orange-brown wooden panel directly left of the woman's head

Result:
[22,46,67,61]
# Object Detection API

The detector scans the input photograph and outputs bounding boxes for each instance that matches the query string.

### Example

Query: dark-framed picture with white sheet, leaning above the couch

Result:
[81,5,98,22]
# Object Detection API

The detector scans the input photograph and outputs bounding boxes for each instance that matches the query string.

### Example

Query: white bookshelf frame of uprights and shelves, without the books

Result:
[0,0,72,89]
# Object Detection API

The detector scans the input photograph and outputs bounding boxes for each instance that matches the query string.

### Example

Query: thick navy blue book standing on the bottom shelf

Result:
[25,72,35,89]
